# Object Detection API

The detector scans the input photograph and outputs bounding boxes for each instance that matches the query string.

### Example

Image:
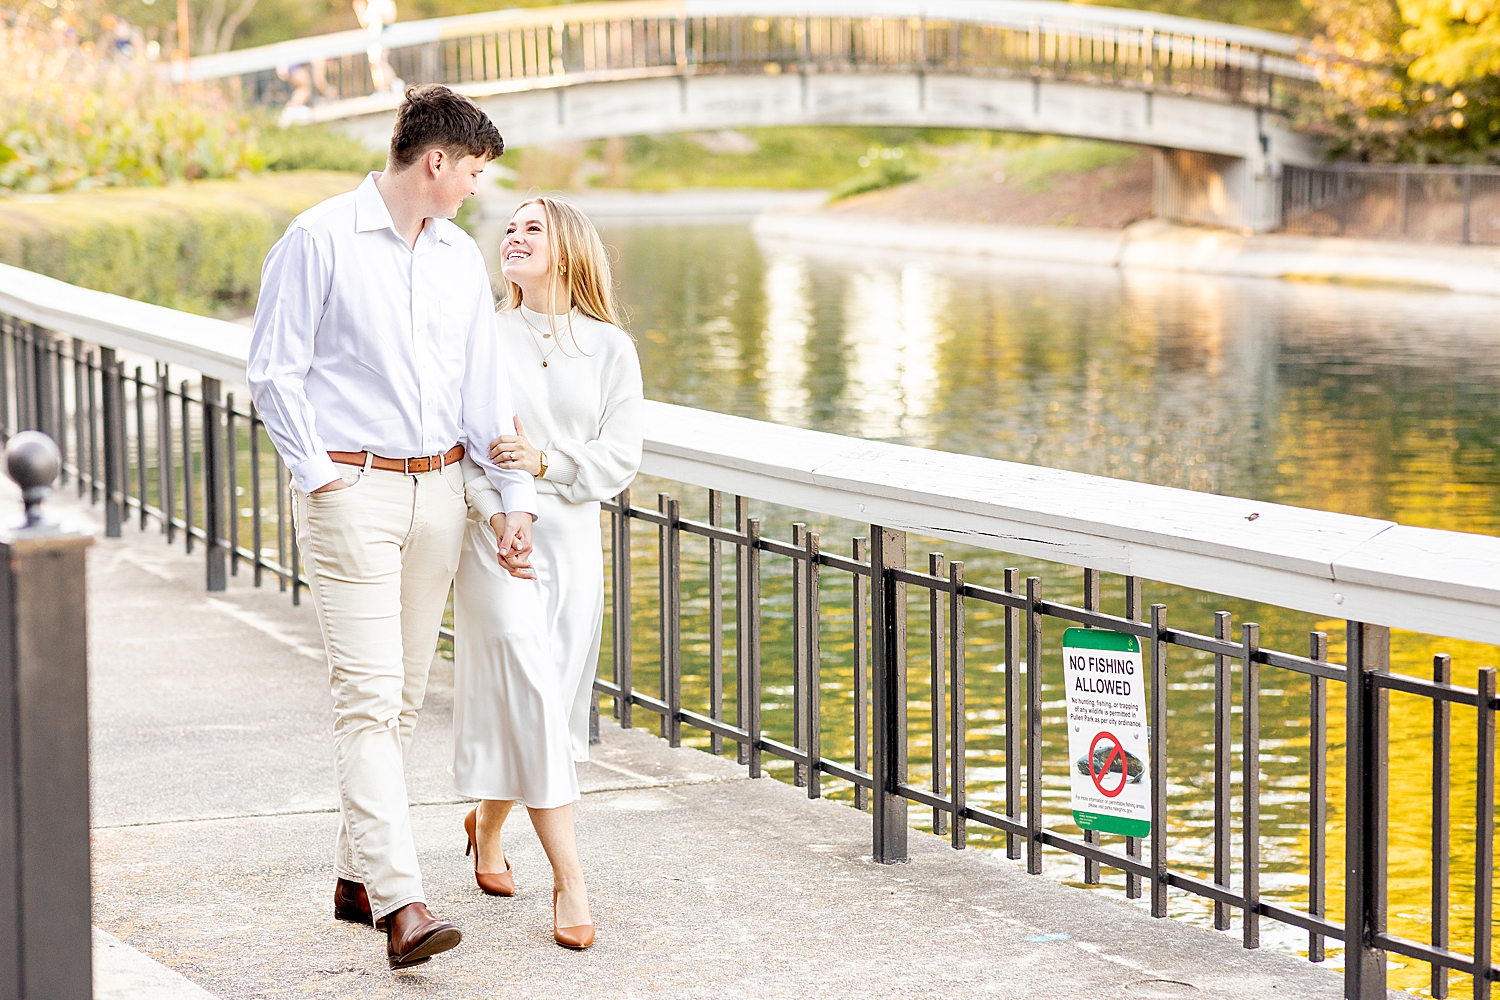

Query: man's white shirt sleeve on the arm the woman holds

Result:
[459,262,537,520]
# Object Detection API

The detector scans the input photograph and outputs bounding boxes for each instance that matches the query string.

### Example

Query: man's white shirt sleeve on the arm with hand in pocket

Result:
[246,226,339,493]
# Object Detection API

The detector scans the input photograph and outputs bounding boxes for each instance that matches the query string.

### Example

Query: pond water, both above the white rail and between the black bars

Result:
[489,223,1500,990]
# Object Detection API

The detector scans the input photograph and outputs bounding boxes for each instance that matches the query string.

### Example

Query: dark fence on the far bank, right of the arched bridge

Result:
[1281,163,1500,244]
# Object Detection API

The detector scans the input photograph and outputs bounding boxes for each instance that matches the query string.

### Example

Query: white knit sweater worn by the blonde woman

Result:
[464,306,642,520]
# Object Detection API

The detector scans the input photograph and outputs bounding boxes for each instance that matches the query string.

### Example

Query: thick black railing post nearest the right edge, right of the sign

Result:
[1344,622,1391,1000]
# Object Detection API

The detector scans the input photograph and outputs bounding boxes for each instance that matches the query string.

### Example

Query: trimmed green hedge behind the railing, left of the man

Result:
[0,171,360,315]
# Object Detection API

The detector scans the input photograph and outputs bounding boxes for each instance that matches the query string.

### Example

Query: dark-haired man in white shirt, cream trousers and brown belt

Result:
[248,85,537,969]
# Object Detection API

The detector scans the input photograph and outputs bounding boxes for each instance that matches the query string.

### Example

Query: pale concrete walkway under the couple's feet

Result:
[70,494,1368,1000]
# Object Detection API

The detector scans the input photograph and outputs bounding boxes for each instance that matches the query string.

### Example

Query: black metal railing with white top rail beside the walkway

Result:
[0,267,1500,1000]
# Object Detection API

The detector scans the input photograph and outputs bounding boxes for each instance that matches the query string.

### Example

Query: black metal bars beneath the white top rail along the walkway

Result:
[0,308,1500,1000]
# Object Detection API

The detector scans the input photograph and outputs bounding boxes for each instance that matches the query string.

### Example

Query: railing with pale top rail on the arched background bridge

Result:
[184,0,1320,118]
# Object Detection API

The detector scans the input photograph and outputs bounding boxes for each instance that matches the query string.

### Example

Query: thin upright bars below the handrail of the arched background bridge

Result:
[217,4,1320,118]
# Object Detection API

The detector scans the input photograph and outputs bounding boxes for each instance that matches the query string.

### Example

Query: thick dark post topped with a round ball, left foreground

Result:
[0,433,93,1000]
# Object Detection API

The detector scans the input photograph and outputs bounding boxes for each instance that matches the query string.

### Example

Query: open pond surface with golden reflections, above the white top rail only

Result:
[608,225,1500,534]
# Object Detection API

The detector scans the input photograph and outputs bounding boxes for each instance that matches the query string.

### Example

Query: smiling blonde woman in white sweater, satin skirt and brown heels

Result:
[453,198,641,949]
